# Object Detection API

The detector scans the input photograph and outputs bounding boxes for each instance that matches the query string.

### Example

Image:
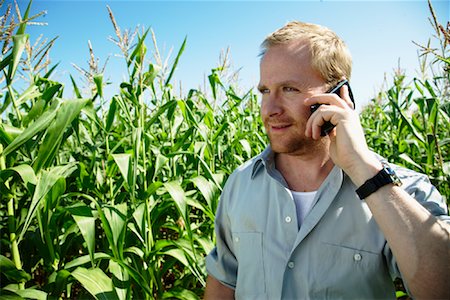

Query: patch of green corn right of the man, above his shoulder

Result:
[361,3,450,204]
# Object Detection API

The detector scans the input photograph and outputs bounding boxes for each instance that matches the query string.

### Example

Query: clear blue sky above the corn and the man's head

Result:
[6,0,450,107]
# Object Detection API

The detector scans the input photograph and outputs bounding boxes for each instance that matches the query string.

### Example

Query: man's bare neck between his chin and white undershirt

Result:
[275,153,334,192]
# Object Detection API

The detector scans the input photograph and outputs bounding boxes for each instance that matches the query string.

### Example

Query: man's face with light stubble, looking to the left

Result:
[258,41,326,155]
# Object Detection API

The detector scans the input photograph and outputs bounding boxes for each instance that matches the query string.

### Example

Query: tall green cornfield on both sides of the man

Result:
[0,3,450,299]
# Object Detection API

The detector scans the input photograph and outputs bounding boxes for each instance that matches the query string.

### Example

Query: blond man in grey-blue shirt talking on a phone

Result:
[205,22,450,299]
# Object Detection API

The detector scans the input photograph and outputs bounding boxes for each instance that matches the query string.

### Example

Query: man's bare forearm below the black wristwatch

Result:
[353,164,450,299]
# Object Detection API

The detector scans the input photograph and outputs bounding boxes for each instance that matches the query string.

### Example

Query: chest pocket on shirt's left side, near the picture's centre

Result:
[233,232,266,299]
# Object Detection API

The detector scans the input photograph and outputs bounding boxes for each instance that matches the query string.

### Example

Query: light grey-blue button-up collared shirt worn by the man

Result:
[206,148,448,299]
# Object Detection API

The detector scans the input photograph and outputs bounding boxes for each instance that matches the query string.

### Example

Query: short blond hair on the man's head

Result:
[261,21,352,85]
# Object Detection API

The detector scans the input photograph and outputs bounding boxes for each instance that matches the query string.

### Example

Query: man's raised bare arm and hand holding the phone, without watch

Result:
[305,87,450,299]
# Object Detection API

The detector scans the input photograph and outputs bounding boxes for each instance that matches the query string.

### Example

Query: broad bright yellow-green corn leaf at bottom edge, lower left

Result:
[72,267,119,300]
